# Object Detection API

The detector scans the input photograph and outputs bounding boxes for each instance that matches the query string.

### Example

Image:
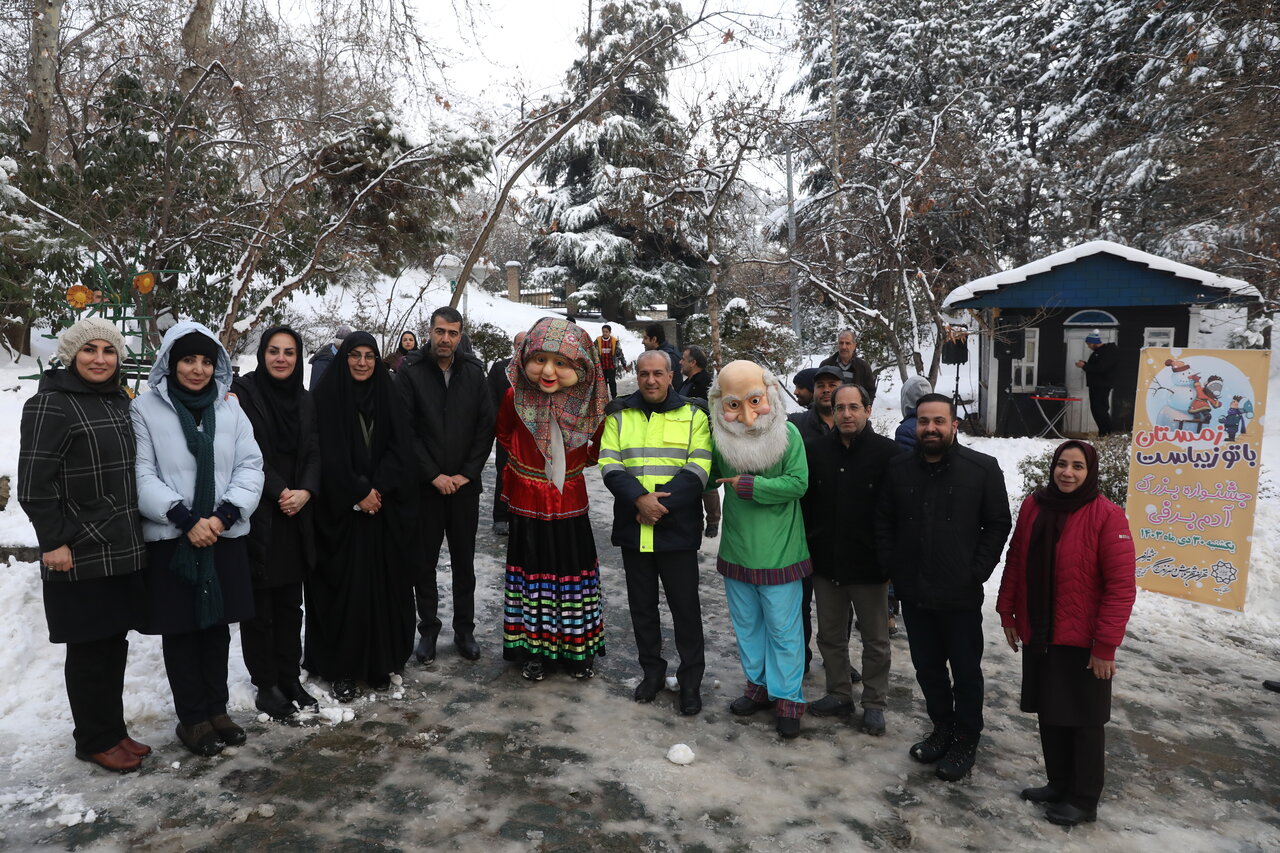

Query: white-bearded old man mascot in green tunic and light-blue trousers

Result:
[708,361,813,738]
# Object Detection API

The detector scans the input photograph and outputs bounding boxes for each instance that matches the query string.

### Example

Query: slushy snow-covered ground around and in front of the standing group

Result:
[0,291,1280,853]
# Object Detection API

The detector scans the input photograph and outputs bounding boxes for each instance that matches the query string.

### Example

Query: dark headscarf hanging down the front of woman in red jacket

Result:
[1027,439,1100,652]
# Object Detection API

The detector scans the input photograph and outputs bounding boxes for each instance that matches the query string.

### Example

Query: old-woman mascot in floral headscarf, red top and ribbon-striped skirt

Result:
[498,318,609,681]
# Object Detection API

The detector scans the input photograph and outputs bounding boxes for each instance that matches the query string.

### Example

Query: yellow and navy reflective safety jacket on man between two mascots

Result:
[600,389,712,552]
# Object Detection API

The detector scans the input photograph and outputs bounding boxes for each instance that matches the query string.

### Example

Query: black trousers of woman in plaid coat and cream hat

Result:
[63,633,129,753]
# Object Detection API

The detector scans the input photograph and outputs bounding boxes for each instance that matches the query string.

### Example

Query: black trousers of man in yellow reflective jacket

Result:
[622,548,707,688]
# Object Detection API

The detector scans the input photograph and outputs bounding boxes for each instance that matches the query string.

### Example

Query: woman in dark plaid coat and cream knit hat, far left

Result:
[18,318,151,772]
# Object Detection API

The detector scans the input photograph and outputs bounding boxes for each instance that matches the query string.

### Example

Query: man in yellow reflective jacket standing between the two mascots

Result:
[600,350,712,715]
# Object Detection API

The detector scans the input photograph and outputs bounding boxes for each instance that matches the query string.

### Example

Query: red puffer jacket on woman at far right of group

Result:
[996,496,1138,661]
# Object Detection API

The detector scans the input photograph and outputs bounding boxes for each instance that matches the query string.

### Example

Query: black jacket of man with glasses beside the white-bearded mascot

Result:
[800,424,906,585]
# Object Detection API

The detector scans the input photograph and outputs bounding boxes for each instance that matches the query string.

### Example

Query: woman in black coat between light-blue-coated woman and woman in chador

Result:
[232,325,320,720]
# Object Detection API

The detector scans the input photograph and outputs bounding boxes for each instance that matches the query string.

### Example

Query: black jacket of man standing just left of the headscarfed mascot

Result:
[396,352,497,494]
